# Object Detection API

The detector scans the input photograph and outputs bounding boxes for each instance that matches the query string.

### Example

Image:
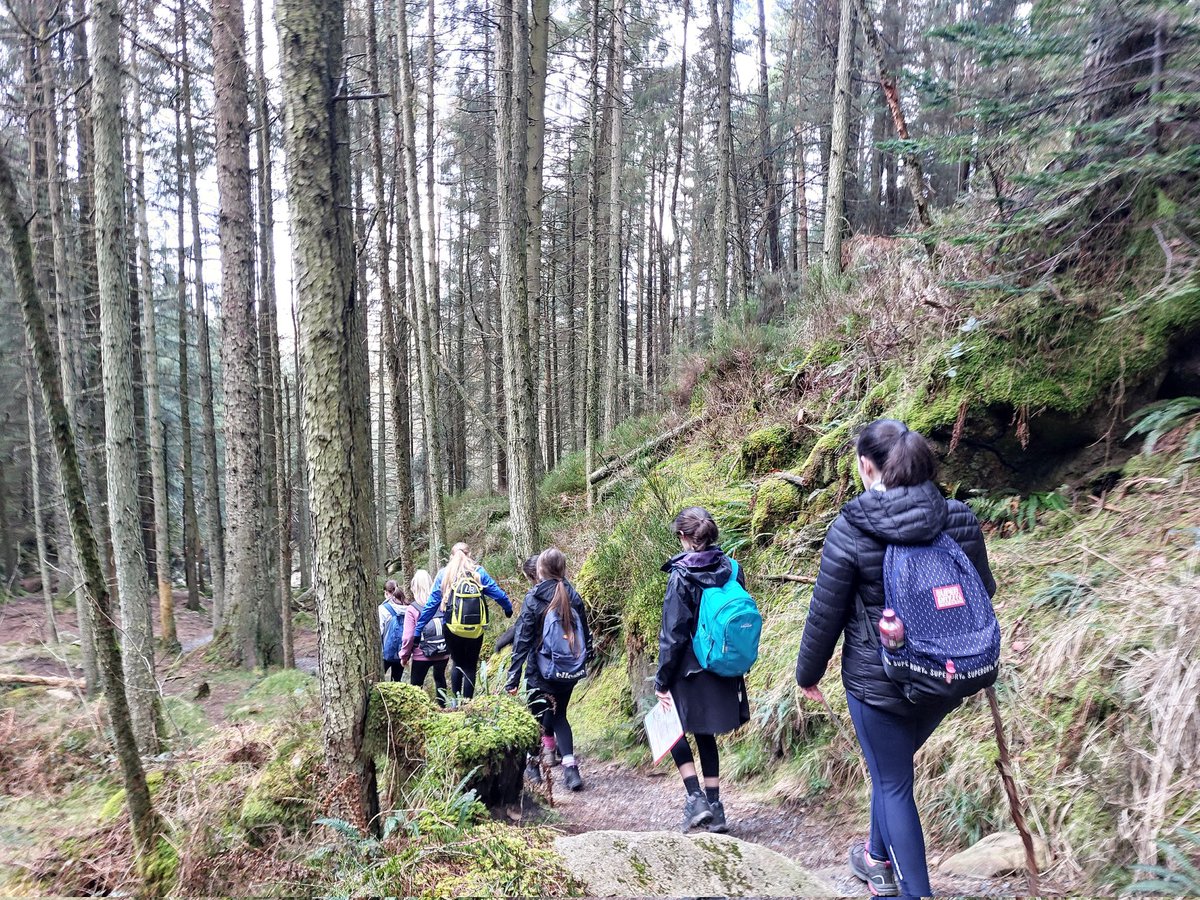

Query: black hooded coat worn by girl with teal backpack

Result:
[654,547,750,734]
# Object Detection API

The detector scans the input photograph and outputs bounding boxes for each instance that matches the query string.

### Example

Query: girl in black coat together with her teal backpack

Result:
[654,506,762,832]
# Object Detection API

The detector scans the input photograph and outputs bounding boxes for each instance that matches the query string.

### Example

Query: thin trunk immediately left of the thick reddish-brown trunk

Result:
[179,4,228,632]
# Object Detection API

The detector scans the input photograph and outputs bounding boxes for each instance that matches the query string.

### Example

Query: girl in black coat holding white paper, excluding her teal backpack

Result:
[654,506,750,832]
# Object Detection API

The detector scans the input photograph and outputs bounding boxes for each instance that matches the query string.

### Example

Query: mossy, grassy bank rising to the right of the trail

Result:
[557,248,1200,886]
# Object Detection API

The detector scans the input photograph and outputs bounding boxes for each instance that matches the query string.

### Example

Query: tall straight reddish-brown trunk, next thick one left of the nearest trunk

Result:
[216,0,280,668]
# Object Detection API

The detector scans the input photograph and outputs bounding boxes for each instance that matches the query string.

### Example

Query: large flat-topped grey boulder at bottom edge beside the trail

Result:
[554,832,838,896]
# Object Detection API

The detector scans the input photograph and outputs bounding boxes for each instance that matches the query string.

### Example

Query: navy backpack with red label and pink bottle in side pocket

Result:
[868,534,1000,706]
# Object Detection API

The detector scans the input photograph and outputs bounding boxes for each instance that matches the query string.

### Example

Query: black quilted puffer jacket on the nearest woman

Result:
[796,481,996,714]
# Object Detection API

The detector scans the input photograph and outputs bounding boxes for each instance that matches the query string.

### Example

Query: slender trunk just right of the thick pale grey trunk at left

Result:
[132,35,179,653]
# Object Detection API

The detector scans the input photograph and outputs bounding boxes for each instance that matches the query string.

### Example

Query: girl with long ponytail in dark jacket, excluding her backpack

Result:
[506,547,592,791]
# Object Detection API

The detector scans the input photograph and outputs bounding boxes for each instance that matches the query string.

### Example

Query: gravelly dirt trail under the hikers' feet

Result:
[540,760,1057,896]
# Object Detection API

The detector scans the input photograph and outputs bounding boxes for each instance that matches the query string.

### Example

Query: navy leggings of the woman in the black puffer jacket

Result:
[846,694,954,896]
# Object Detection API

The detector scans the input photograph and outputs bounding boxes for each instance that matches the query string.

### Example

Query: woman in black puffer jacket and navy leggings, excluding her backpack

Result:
[796,419,996,896]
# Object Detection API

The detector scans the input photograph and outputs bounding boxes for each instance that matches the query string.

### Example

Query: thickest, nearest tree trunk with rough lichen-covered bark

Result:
[276,0,379,829]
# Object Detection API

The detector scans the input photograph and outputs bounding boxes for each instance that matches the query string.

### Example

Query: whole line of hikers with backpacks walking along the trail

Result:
[379,419,1000,898]
